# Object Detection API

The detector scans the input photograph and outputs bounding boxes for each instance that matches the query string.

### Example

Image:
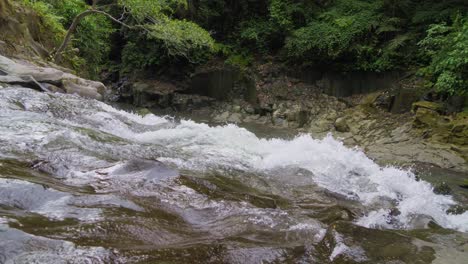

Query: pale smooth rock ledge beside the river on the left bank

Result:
[0,56,106,100]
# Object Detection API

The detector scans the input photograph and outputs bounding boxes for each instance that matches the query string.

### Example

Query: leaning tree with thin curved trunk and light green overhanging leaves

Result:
[53,0,214,61]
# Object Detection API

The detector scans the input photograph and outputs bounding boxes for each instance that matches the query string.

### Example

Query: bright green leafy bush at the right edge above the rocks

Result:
[419,16,468,95]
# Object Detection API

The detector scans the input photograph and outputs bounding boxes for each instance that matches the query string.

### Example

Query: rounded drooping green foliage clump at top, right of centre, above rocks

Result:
[285,0,388,68]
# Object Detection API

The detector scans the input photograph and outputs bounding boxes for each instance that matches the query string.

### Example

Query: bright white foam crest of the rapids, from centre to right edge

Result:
[91,109,468,232]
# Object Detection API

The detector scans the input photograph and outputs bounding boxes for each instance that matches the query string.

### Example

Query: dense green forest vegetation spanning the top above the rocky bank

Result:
[19,0,468,94]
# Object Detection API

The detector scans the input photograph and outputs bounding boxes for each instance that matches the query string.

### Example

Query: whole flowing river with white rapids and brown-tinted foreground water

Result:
[0,87,468,263]
